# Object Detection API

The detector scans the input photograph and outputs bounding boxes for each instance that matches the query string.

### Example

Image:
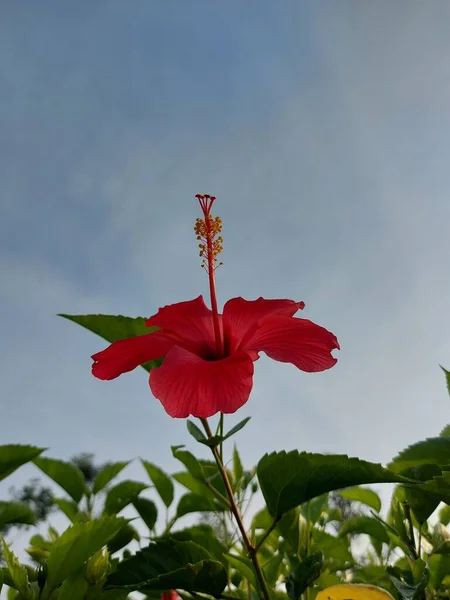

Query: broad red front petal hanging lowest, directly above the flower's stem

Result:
[150,346,253,419]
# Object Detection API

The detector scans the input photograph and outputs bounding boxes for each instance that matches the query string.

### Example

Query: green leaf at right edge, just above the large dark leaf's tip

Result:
[388,437,450,473]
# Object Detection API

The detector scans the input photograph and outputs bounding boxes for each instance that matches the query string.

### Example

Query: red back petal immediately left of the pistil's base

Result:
[145,296,216,356]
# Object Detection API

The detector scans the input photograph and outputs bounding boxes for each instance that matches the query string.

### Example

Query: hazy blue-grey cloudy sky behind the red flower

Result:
[0,0,450,536]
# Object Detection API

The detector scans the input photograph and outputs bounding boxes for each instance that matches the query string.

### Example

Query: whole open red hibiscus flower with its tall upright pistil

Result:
[92,196,339,418]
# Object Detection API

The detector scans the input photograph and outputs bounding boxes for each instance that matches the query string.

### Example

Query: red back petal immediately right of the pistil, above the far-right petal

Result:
[223,298,305,353]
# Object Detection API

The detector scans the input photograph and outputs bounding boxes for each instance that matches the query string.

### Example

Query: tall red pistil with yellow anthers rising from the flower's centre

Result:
[194,194,224,358]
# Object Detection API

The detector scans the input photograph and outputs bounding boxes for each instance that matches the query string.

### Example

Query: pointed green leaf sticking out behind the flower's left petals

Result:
[58,314,162,371]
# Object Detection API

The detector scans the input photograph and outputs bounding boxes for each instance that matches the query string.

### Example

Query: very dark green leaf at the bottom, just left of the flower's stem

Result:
[106,540,227,597]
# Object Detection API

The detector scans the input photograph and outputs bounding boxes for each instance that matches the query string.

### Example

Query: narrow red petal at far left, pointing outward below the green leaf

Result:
[92,332,174,379]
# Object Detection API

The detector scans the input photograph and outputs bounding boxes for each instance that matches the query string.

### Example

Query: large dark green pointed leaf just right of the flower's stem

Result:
[257,450,407,517]
